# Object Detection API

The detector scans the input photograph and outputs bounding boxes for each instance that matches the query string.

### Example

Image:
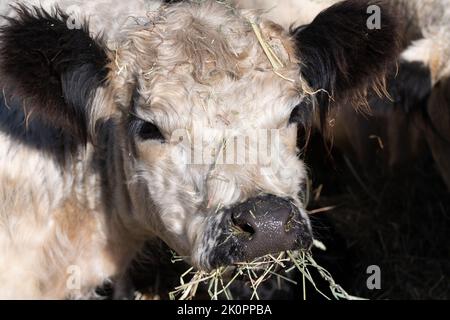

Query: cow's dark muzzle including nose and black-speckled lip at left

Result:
[201,195,313,269]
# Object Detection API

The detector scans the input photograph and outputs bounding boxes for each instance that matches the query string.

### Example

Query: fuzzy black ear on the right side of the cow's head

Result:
[291,0,399,127]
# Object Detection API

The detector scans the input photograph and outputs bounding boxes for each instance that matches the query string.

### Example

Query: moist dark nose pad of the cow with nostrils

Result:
[231,195,313,259]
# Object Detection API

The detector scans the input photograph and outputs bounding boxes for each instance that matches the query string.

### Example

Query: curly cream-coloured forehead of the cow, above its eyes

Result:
[114,2,307,131]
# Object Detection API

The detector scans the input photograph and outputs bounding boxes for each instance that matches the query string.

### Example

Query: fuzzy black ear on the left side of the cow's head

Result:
[0,6,108,142]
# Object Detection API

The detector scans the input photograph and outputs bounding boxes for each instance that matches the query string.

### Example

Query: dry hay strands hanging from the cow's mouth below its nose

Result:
[169,240,361,300]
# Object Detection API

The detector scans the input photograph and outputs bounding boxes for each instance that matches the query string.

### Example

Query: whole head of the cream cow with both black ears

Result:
[0,1,396,269]
